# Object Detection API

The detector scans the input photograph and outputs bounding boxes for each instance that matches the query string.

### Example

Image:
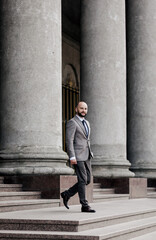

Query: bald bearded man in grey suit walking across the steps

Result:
[61,102,95,213]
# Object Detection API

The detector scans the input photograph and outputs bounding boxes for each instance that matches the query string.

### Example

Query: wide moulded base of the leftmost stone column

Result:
[0,147,74,175]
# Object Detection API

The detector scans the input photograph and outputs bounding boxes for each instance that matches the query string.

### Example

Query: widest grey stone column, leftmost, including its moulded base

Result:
[0,0,72,174]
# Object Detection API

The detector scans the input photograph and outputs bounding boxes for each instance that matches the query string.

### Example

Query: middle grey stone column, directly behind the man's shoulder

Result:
[81,0,134,178]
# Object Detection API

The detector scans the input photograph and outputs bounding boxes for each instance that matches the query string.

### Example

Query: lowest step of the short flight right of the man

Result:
[93,193,129,203]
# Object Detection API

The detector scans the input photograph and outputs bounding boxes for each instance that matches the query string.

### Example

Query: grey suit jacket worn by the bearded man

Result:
[66,116,93,161]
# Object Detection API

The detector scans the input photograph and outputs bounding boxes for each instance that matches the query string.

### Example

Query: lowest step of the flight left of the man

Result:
[0,199,60,212]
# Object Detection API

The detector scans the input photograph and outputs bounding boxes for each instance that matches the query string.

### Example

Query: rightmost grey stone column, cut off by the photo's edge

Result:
[127,0,156,178]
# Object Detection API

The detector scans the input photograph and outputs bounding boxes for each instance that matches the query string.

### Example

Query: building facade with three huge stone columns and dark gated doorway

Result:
[0,0,156,184]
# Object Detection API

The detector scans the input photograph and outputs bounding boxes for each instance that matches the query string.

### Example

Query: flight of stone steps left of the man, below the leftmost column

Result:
[0,177,60,212]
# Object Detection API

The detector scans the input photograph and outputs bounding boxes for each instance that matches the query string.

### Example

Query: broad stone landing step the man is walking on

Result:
[0,199,156,232]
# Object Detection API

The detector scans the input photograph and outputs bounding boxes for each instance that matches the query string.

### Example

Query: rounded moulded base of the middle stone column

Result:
[92,158,135,178]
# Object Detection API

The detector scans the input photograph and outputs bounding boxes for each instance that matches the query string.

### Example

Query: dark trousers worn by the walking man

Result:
[65,159,91,207]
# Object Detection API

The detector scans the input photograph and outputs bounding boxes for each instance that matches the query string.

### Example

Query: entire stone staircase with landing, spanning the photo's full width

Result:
[0,177,156,240]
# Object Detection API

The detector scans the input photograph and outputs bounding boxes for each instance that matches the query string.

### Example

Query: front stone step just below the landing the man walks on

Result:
[0,217,156,240]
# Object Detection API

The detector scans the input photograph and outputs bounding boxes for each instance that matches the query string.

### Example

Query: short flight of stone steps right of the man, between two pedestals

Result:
[93,183,129,203]
